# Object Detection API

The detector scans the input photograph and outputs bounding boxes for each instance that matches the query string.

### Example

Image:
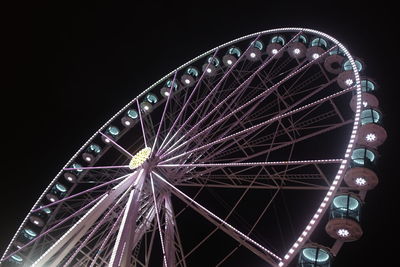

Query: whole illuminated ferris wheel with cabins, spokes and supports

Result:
[1,28,386,267]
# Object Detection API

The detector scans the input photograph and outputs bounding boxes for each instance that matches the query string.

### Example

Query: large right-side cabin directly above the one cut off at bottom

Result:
[325,194,363,242]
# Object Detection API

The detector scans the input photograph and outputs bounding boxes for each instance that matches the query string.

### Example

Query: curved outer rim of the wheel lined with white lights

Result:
[2,28,361,266]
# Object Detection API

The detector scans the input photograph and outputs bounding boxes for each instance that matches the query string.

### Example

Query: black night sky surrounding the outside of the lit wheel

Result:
[0,1,400,267]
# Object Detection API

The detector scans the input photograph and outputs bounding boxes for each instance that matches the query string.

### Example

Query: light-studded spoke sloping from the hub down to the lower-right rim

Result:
[153,172,280,265]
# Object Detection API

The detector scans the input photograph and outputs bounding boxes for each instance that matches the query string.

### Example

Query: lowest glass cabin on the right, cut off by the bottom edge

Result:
[297,244,332,267]
